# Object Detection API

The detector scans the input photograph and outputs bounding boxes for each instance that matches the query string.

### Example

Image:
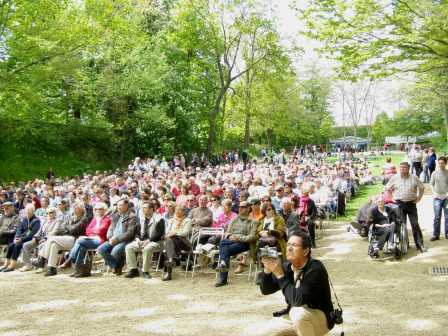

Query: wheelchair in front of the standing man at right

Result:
[367,204,409,259]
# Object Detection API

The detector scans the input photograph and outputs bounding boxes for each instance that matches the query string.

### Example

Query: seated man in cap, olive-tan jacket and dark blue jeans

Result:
[215,201,257,287]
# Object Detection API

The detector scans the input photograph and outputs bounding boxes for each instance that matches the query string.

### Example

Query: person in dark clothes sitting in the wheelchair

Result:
[369,196,396,258]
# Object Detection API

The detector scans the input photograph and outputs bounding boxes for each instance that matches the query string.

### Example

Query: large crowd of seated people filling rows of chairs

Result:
[0,151,369,286]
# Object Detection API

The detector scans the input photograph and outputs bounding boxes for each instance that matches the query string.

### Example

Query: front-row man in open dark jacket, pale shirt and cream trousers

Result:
[125,202,165,279]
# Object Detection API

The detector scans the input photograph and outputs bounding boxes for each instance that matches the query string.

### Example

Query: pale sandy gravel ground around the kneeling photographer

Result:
[0,196,448,336]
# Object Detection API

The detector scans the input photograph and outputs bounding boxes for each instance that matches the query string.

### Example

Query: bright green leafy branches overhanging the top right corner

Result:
[301,0,448,77]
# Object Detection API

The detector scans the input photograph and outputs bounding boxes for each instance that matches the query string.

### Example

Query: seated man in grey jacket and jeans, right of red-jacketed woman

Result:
[98,199,137,275]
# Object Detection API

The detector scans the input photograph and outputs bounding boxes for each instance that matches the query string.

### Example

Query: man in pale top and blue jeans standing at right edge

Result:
[429,156,448,241]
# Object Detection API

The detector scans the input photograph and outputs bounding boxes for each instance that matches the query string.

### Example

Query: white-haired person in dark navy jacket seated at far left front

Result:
[0,204,40,272]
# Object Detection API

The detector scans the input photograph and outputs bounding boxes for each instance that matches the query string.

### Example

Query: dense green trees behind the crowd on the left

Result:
[0,0,333,166]
